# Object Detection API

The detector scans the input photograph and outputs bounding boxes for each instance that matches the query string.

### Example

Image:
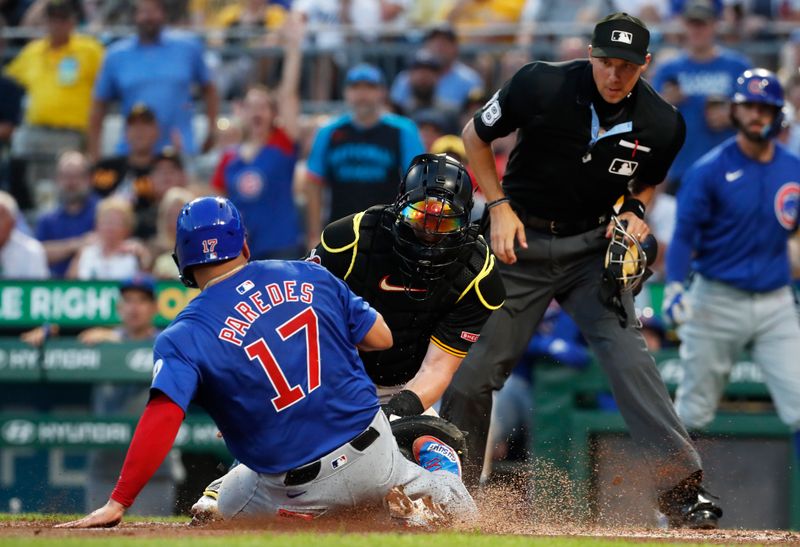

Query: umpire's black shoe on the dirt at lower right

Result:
[658,471,722,530]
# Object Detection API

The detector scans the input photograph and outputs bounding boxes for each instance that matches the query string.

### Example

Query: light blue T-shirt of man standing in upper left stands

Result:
[94,30,211,155]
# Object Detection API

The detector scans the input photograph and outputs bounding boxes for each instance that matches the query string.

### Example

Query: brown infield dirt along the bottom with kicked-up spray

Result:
[0,469,800,547]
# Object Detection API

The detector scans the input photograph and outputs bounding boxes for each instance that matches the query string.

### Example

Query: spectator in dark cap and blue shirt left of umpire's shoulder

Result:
[390,26,484,117]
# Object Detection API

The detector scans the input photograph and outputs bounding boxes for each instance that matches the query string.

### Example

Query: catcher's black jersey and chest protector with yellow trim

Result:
[308,205,505,387]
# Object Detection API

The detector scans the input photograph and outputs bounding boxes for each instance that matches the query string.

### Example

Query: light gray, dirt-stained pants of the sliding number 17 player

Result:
[214,410,477,521]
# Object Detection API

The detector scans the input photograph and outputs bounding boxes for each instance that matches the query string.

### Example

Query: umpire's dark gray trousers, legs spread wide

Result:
[440,226,701,488]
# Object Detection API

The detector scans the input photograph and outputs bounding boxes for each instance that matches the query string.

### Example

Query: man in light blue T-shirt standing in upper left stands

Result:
[89,0,218,161]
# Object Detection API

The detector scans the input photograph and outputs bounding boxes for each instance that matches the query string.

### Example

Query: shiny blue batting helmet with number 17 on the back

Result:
[172,196,245,287]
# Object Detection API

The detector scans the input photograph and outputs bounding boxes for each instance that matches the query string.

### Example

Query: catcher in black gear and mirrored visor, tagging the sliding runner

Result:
[192,154,505,520]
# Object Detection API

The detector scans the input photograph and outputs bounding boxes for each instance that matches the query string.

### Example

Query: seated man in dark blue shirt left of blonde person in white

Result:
[36,152,98,278]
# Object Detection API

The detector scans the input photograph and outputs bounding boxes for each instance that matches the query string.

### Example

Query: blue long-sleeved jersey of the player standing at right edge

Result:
[667,138,800,292]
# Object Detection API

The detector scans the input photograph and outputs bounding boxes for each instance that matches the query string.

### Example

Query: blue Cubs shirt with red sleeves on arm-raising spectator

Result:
[211,128,303,258]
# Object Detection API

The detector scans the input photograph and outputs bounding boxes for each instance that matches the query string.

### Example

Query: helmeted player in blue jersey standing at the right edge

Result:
[664,68,800,454]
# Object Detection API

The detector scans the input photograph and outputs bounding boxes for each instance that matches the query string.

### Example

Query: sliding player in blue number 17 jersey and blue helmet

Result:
[65,197,476,528]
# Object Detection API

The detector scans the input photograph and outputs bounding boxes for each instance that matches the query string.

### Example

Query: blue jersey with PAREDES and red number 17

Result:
[152,261,379,473]
